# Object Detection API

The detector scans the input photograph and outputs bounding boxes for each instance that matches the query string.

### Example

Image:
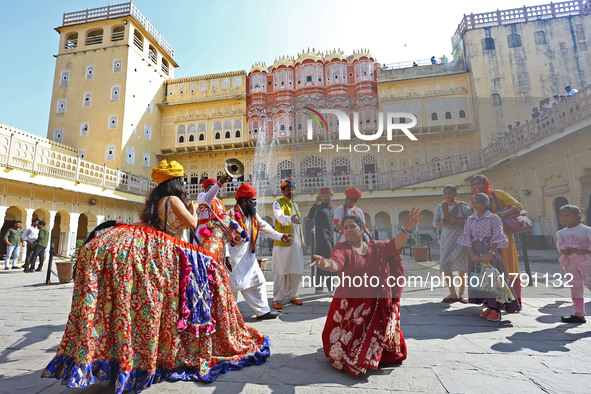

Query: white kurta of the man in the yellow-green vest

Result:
[273,201,304,275]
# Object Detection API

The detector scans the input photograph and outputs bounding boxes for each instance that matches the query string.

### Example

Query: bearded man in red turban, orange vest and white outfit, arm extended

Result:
[226,183,291,320]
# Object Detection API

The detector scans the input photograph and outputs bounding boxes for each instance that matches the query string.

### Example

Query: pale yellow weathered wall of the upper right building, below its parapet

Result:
[463,15,591,146]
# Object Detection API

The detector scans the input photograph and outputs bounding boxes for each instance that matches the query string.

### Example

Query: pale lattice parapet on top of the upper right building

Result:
[452,0,591,46]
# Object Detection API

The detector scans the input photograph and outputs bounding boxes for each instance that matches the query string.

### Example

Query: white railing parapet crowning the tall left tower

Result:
[62,2,174,59]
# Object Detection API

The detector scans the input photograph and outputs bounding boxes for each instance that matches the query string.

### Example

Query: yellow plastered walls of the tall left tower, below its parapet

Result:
[47,16,174,176]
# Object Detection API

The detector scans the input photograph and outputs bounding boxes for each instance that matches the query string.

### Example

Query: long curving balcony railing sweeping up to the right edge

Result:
[188,85,591,199]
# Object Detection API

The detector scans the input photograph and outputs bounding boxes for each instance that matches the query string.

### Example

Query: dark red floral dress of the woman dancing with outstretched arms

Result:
[322,240,406,375]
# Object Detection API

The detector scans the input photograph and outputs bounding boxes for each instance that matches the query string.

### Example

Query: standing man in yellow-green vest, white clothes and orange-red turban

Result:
[273,178,306,309]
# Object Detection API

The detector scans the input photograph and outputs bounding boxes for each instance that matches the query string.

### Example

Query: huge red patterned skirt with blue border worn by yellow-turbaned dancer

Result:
[42,224,270,393]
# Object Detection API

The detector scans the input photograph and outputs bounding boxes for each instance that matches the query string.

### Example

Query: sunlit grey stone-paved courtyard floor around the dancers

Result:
[0,251,591,394]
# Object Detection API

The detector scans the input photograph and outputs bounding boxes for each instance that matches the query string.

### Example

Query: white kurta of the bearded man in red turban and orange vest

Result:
[227,210,283,292]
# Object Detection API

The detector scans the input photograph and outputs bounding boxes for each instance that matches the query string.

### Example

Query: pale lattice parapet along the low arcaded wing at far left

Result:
[0,124,155,195]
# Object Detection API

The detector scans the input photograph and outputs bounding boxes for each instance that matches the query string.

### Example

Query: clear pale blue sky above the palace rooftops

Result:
[0,0,549,137]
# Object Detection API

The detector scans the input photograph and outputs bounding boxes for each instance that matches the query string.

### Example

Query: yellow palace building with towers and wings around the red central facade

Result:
[0,3,591,262]
